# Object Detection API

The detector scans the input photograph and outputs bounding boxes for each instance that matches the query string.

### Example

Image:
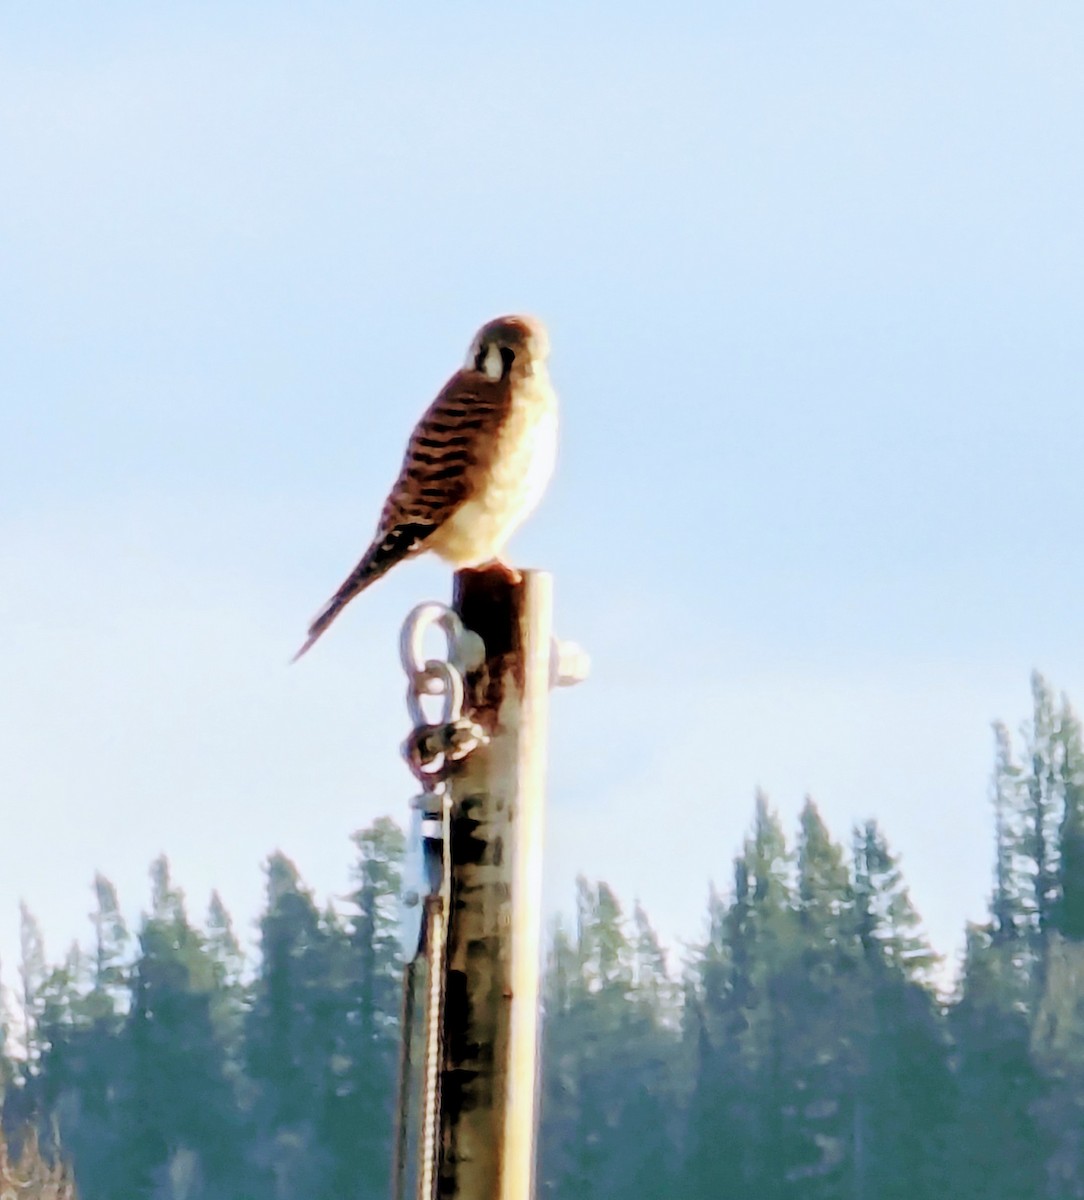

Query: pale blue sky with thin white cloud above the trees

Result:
[0,0,1084,984]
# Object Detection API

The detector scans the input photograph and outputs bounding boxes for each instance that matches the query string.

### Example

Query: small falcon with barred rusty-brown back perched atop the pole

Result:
[294,317,557,661]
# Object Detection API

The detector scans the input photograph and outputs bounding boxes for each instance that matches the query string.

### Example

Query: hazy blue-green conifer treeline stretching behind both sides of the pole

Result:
[0,676,1084,1200]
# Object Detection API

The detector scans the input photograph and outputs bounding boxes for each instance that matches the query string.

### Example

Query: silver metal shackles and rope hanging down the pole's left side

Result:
[394,604,489,1200]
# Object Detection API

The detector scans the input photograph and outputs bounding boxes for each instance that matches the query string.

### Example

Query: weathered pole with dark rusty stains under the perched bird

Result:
[437,569,552,1200]
